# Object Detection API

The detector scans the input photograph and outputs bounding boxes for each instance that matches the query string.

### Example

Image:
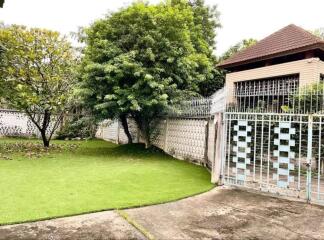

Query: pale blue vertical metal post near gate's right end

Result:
[306,115,313,202]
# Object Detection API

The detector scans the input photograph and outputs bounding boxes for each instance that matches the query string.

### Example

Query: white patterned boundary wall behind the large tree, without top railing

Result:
[96,119,215,168]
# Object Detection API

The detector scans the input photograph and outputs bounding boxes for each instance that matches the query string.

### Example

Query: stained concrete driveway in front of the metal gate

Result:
[0,188,324,240]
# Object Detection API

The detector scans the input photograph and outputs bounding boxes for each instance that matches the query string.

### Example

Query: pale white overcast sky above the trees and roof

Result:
[0,0,324,54]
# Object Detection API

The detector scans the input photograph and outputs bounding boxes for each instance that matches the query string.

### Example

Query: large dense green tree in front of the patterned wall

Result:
[81,0,219,147]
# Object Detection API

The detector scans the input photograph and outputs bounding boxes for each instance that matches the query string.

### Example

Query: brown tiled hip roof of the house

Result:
[218,24,324,68]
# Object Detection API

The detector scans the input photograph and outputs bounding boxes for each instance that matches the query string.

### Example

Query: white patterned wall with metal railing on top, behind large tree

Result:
[96,89,225,169]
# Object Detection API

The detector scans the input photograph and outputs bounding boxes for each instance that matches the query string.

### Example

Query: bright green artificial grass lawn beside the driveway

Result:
[0,139,213,225]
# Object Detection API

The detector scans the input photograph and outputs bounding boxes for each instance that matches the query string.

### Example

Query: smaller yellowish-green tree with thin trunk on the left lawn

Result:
[0,25,76,147]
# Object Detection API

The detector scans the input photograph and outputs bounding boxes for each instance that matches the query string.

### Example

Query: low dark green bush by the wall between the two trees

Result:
[56,116,97,140]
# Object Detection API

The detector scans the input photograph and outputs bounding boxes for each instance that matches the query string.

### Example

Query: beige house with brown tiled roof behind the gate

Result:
[218,24,324,108]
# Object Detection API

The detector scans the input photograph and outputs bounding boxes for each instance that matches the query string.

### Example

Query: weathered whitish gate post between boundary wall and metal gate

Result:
[212,113,223,183]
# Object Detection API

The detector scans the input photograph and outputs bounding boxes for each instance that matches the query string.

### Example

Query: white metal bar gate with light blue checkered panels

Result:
[222,112,324,204]
